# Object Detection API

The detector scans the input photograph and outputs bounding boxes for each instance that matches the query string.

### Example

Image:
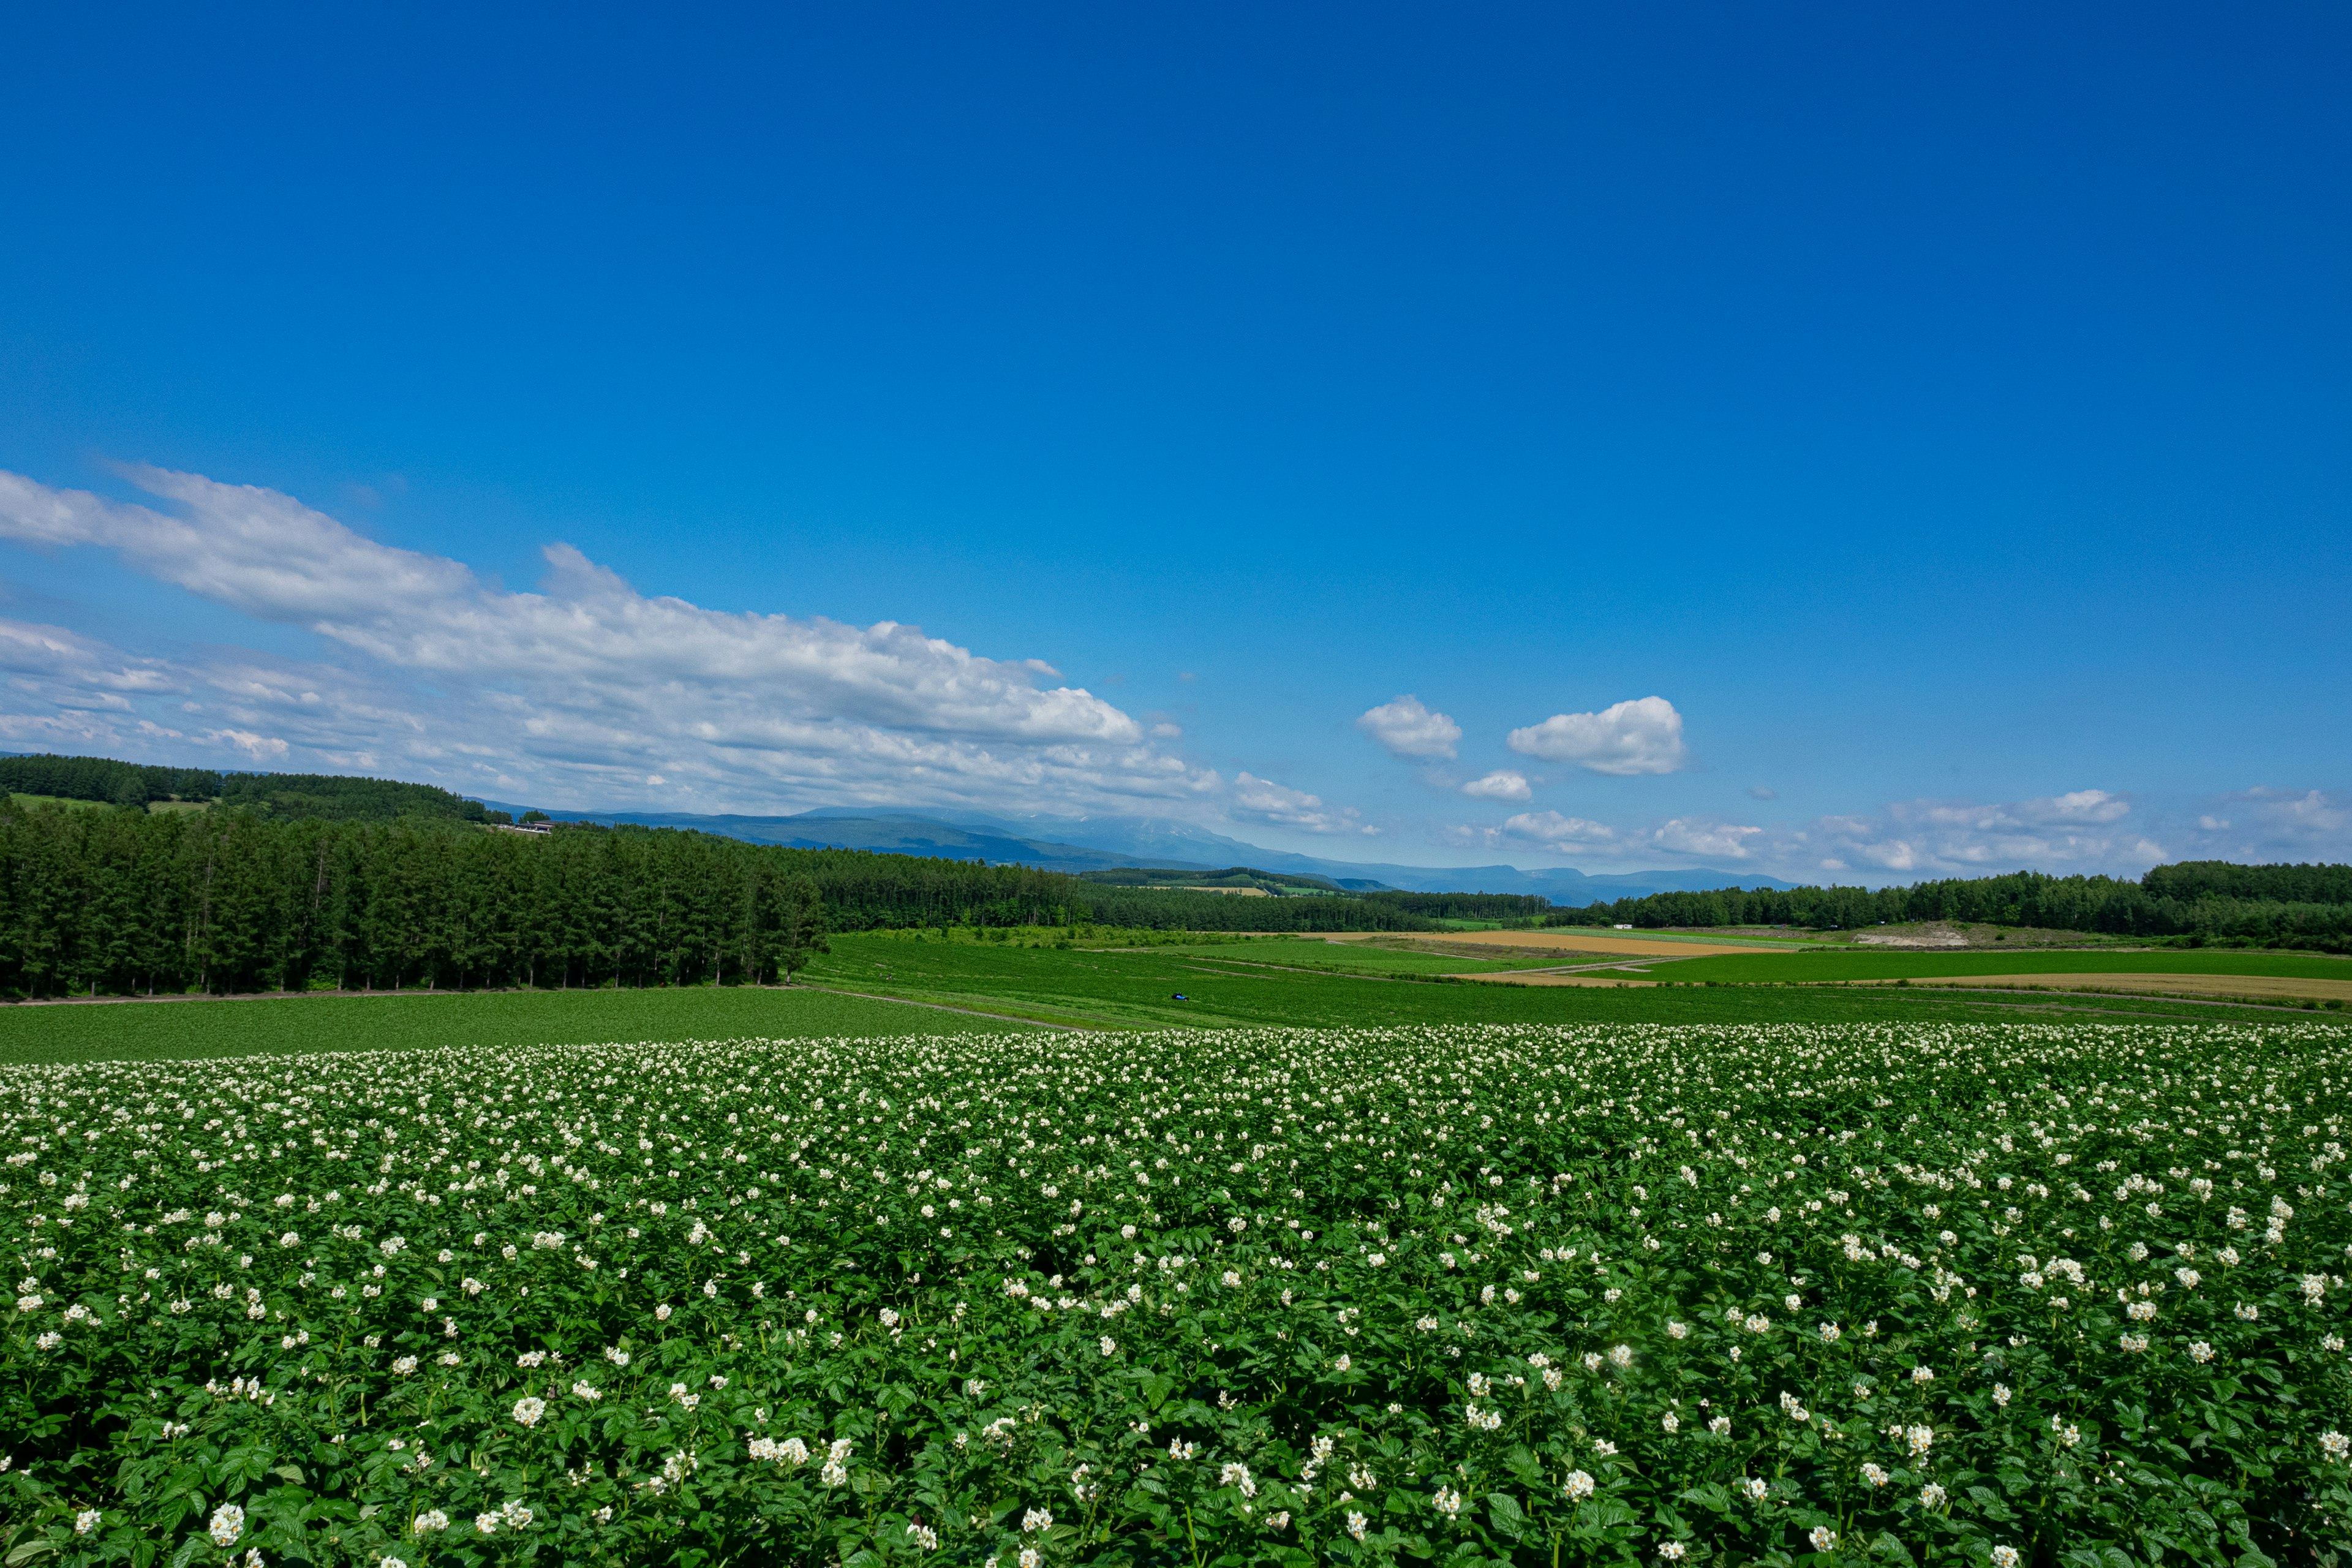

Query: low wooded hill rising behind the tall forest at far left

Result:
[0,755,506,823]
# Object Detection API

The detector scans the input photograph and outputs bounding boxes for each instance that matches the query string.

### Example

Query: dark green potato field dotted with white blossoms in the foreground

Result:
[0,1025,2352,1568]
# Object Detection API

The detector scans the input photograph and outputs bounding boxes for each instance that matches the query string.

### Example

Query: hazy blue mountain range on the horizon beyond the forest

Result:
[484,802,1795,905]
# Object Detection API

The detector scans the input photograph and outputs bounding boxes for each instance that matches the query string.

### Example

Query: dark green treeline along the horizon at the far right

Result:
[1545,861,2352,952]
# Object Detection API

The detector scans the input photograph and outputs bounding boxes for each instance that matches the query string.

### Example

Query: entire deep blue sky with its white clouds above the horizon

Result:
[0,5,2352,881]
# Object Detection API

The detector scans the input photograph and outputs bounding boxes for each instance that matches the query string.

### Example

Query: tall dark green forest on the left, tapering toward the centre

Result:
[0,802,1430,997]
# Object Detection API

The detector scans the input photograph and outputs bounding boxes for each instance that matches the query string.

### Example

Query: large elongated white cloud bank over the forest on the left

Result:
[0,468,1221,806]
